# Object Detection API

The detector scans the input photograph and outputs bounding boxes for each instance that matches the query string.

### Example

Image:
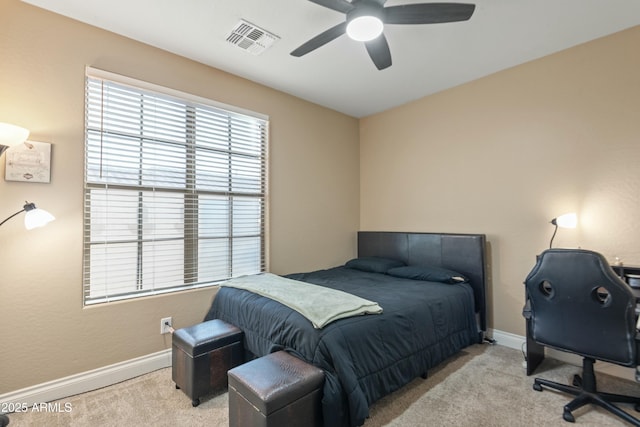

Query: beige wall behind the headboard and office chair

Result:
[360,27,640,335]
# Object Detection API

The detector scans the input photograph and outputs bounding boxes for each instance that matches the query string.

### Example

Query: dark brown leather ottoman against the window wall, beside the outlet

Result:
[171,319,244,406]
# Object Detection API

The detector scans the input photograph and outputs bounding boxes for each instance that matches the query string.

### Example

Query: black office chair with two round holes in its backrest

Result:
[524,249,640,426]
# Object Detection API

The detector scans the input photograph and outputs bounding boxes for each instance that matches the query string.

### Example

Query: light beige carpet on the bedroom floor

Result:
[10,345,640,427]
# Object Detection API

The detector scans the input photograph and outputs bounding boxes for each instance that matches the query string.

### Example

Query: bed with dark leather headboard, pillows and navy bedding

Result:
[205,232,486,426]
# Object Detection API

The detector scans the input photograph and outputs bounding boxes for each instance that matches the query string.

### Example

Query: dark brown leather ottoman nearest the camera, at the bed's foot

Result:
[228,351,324,427]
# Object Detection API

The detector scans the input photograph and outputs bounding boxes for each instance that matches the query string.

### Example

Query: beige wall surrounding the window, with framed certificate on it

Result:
[0,0,359,394]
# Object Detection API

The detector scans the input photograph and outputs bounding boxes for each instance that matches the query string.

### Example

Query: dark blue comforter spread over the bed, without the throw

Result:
[205,267,480,427]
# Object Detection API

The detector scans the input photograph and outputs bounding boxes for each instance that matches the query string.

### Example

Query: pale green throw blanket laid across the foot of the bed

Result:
[220,273,382,329]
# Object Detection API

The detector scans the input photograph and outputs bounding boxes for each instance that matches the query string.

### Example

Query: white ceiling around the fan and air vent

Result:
[23,0,640,117]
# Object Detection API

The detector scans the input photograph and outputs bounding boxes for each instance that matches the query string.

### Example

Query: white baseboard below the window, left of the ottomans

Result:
[0,349,171,406]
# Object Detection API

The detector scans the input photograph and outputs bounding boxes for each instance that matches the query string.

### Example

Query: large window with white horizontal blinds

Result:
[83,68,268,304]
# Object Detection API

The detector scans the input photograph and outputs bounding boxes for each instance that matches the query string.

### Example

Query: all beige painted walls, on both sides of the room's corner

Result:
[0,0,640,394]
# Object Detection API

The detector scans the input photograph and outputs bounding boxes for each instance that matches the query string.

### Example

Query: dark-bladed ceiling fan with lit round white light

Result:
[291,0,476,70]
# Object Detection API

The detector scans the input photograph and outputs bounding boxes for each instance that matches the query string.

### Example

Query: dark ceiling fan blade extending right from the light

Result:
[384,3,476,24]
